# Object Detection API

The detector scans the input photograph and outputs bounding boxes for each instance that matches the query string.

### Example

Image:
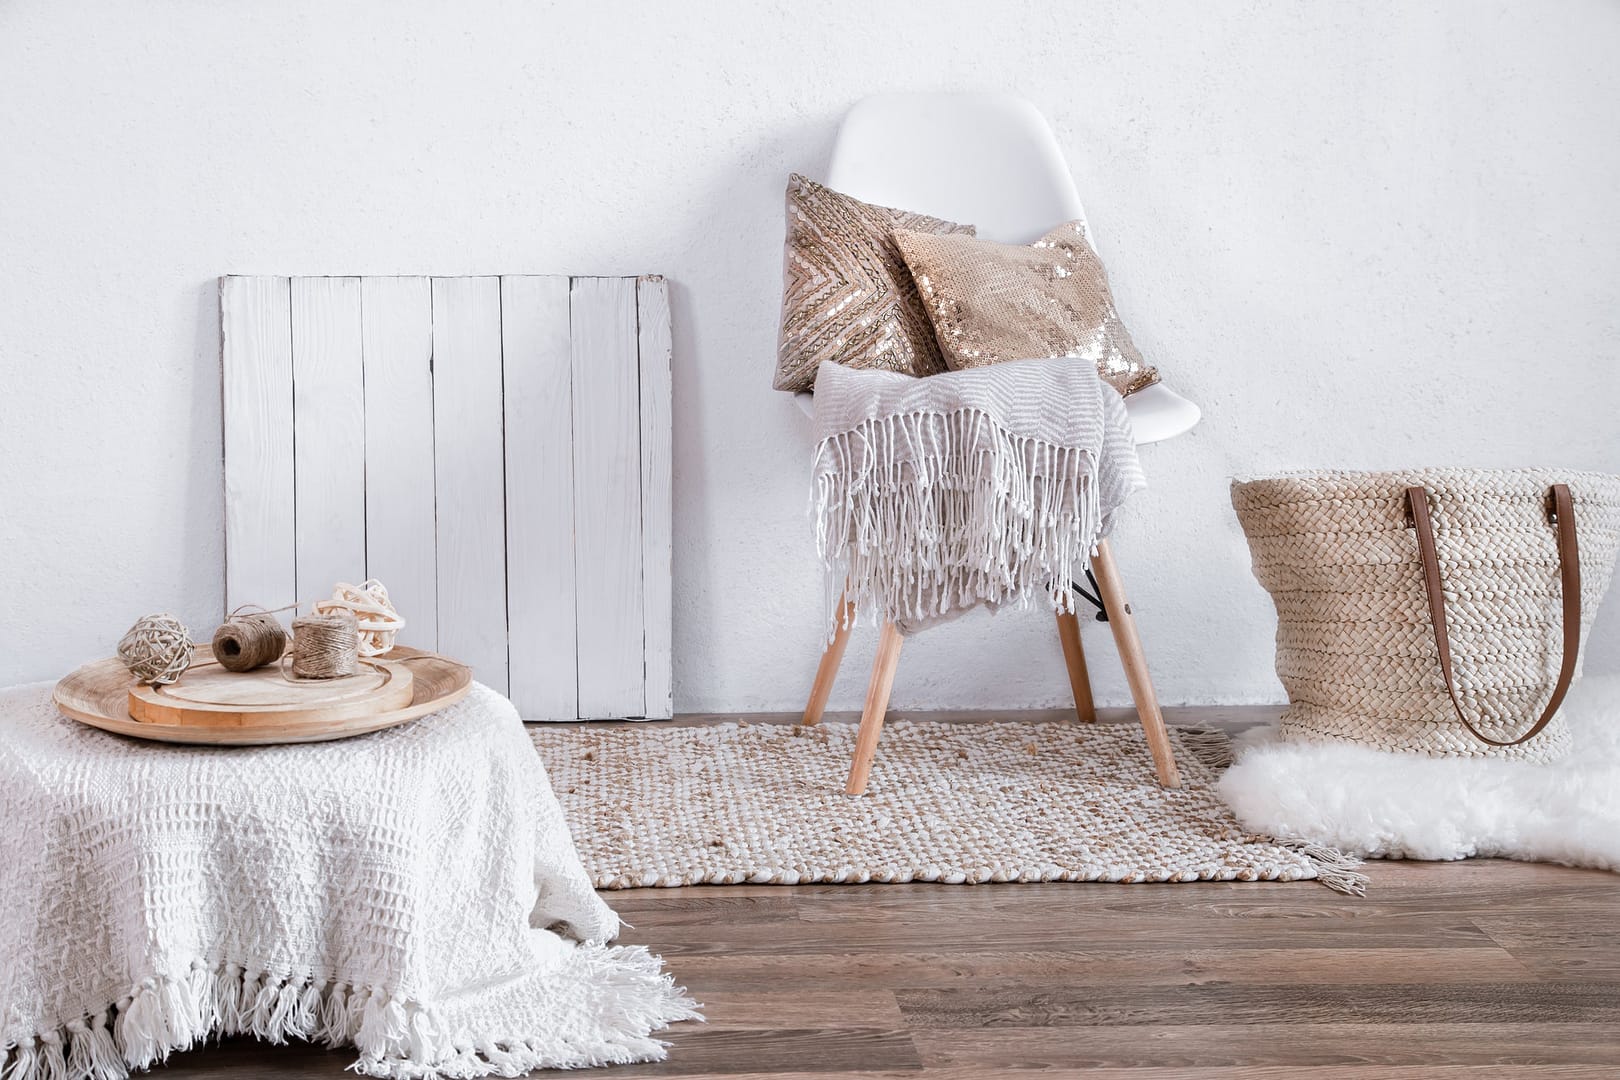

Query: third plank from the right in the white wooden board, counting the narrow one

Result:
[501,277,580,721]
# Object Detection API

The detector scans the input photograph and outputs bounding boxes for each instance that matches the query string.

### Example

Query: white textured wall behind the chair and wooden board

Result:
[0,0,1620,711]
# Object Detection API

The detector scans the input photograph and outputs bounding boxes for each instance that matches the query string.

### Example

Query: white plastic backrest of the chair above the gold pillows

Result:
[826,94,1090,243]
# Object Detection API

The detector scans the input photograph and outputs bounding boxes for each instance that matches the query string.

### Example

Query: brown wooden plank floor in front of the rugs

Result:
[156,714,1620,1080]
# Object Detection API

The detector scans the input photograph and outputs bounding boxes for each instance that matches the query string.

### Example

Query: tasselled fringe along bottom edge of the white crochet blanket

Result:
[0,946,701,1080]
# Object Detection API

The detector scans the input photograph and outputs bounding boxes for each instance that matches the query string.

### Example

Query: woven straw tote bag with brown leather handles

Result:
[1231,470,1620,761]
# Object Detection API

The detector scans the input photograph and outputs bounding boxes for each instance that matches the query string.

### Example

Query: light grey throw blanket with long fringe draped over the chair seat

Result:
[813,359,1145,633]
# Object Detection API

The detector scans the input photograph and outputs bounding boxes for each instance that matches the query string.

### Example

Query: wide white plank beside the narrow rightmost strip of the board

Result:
[569,277,646,719]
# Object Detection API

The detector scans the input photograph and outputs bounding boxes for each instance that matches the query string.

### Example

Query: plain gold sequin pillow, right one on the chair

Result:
[894,222,1158,393]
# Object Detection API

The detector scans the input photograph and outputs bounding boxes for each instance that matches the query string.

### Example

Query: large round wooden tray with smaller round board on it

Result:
[52,646,473,746]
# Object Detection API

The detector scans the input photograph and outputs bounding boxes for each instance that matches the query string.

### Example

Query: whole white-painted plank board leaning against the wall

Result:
[220,277,672,719]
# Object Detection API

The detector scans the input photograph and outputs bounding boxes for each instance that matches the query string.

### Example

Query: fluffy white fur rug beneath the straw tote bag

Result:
[1218,675,1620,871]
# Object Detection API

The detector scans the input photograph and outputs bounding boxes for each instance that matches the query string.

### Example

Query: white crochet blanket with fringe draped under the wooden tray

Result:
[0,685,695,1080]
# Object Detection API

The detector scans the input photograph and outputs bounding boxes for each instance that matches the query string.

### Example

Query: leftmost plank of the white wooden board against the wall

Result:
[219,277,298,619]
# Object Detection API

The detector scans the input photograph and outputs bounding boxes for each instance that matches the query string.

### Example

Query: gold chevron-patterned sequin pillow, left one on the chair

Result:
[776,175,974,390]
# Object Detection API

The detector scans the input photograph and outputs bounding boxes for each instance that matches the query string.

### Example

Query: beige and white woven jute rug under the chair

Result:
[530,721,1364,892]
